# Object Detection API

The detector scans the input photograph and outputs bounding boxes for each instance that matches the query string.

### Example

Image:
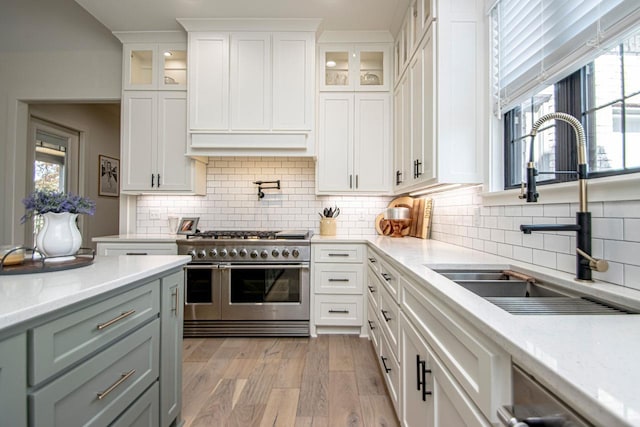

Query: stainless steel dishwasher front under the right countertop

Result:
[498,365,593,427]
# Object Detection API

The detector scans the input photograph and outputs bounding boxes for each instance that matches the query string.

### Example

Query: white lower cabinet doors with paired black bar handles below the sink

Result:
[400,315,491,427]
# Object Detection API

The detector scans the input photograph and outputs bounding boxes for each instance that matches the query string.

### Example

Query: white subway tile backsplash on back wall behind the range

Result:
[137,157,392,237]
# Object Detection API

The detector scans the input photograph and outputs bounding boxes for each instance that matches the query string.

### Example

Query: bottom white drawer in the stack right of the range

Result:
[315,295,363,326]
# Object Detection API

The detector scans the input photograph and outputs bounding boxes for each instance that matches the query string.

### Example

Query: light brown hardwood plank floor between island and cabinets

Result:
[182,335,398,427]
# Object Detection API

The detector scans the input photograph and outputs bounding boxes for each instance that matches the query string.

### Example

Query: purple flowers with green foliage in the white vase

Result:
[21,190,96,224]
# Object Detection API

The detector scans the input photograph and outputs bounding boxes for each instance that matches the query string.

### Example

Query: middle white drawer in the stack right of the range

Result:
[313,264,362,294]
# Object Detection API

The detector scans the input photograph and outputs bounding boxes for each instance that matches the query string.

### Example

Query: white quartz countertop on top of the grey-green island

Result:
[0,255,191,333]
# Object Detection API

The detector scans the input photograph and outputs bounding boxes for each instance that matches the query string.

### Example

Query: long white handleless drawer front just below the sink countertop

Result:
[401,280,510,421]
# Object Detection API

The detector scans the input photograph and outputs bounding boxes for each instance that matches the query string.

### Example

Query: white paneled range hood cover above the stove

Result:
[179,19,317,156]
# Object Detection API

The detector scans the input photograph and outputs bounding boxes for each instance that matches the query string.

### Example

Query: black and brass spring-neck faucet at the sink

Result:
[519,113,609,281]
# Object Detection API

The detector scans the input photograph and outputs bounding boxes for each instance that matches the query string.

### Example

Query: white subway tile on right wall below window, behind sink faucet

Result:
[431,187,640,290]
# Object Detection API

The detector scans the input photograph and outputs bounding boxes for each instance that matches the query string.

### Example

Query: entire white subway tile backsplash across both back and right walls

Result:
[137,157,640,290]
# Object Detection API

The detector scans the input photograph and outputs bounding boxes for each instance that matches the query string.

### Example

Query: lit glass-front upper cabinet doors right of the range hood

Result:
[319,43,391,92]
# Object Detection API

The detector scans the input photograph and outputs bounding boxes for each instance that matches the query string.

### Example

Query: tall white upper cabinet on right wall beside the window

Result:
[392,0,486,193]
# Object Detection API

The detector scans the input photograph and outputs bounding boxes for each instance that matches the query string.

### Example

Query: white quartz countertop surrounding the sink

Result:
[360,237,640,427]
